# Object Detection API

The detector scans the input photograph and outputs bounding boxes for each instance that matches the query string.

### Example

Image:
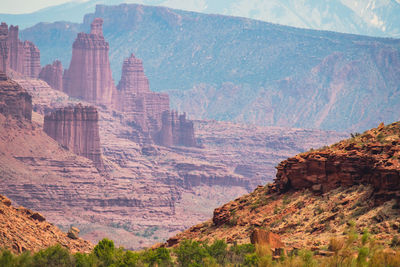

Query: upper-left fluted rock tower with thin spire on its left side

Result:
[7,25,40,78]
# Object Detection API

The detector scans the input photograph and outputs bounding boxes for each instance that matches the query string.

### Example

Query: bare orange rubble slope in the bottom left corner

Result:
[0,195,93,253]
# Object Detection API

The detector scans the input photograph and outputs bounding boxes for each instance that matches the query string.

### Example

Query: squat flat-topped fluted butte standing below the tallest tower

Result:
[43,104,104,169]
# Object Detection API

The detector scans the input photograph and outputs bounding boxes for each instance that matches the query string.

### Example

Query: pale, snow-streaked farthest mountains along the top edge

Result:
[0,0,400,38]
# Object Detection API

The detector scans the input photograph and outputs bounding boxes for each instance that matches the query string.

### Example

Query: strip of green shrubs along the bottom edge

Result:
[0,231,400,267]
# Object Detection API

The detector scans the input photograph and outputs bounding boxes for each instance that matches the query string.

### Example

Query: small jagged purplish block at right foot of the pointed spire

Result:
[156,111,196,147]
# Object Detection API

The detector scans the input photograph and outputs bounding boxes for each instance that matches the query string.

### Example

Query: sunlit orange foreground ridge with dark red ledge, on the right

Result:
[164,122,400,251]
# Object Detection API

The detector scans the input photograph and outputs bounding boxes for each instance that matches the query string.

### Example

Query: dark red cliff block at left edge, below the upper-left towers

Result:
[0,72,32,121]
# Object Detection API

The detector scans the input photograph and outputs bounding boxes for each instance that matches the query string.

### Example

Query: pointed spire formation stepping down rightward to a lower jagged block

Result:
[114,54,196,146]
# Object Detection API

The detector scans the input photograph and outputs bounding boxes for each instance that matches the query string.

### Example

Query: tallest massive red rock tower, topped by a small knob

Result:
[63,18,115,105]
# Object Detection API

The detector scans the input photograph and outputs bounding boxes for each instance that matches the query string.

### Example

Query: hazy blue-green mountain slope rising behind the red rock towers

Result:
[23,5,400,131]
